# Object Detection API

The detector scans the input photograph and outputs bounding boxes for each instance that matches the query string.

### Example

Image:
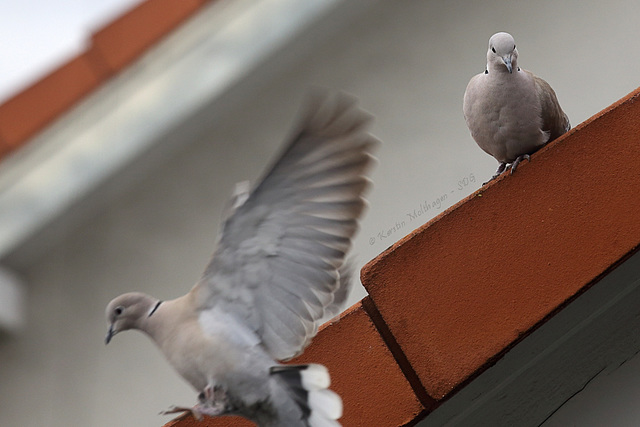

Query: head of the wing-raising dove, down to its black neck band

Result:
[105,292,162,344]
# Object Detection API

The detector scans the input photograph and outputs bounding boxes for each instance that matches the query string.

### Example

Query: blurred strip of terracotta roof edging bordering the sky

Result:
[0,0,211,158]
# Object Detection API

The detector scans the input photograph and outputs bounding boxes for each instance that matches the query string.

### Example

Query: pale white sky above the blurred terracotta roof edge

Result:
[0,0,140,103]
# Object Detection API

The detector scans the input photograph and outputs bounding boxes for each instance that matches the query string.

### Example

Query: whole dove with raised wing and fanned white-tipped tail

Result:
[106,95,377,427]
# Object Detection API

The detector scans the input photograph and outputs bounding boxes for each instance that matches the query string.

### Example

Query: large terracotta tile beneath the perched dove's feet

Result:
[362,89,640,401]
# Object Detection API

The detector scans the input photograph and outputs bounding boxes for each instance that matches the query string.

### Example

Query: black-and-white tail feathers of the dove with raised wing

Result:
[270,364,342,427]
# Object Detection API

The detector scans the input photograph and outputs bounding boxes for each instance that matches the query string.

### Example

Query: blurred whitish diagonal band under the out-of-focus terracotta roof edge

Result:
[0,0,343,259]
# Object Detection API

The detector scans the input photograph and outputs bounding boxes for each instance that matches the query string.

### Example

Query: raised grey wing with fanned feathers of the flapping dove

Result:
[195,95,377,360]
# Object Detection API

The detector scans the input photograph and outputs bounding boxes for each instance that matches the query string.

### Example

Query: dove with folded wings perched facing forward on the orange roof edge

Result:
[463,33,571,179]
